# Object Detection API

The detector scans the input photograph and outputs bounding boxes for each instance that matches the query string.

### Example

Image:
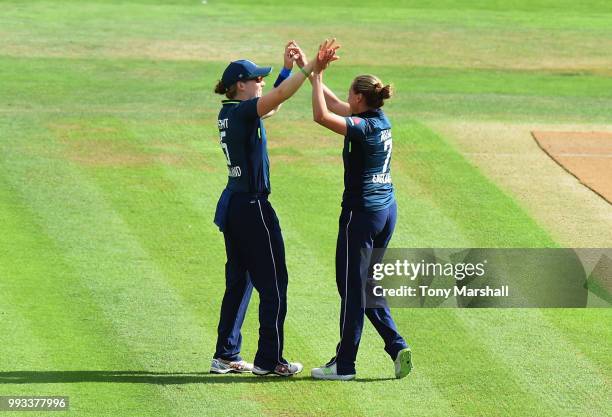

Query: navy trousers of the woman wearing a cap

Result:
[215,194,287,369]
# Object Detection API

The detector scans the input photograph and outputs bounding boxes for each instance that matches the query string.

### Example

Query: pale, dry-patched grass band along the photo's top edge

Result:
[1,2,610,75]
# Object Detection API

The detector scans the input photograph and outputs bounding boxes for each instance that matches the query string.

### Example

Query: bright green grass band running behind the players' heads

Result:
[0,51,612,123]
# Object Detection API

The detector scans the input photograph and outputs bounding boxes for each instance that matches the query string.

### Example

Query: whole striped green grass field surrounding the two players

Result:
[0,0,612,417]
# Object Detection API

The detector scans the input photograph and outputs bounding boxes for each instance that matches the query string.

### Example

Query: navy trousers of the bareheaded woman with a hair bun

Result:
[328,202,408,375]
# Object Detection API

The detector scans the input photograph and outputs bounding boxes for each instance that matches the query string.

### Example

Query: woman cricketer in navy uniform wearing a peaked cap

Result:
[210,42,331,376]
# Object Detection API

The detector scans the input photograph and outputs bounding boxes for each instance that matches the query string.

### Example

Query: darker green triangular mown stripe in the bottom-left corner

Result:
[0,166,177,415]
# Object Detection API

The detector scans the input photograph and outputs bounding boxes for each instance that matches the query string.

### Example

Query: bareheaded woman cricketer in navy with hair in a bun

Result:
[308,39,412,380]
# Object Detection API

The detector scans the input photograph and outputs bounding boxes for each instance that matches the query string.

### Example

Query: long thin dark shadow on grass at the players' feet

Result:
[0,371,395,385]
